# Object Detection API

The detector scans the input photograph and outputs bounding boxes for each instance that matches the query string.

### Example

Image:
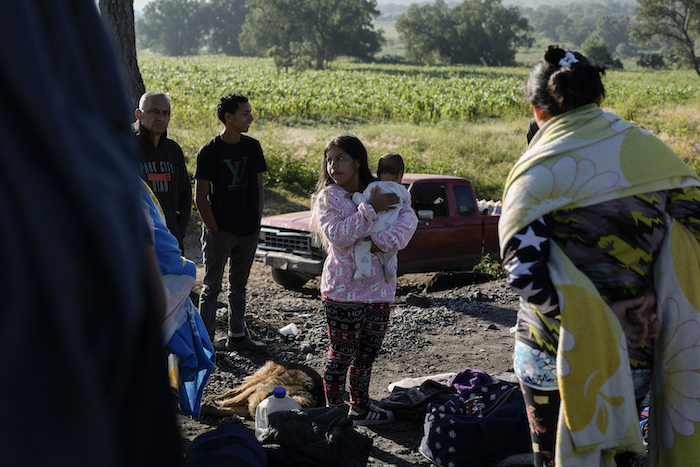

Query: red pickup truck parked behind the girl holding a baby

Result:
[256,174,500,288]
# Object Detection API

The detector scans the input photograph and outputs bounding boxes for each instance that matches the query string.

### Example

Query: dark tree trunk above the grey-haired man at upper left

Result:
[99,0,146,109]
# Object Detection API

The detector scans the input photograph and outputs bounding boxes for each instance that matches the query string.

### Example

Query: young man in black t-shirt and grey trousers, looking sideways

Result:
[194,94,267,352]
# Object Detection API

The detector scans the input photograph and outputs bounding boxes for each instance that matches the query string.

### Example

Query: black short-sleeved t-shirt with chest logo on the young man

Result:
[194,135,267,235]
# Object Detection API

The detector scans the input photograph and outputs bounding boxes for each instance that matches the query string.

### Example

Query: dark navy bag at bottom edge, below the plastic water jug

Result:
[185,425,267,467]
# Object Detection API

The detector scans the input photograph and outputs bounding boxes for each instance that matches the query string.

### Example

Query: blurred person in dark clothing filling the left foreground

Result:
[0,0,184,467]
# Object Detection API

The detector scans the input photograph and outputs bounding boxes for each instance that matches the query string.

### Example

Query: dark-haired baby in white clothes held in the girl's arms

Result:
[352,152,411,281]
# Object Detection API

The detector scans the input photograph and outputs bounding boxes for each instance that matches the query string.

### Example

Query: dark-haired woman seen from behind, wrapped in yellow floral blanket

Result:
[499,47,700,467]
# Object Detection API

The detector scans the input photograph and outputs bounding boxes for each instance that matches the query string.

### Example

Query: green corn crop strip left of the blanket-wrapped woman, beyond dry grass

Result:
[141,56,525,124]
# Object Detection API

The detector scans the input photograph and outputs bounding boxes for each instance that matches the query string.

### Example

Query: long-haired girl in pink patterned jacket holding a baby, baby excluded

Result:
[312,135,418,425]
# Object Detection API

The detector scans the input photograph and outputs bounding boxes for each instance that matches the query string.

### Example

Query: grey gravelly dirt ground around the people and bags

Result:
[179,214,517,467]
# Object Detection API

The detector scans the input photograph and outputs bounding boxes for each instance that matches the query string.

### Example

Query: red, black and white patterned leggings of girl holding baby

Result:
[323,299,391,412]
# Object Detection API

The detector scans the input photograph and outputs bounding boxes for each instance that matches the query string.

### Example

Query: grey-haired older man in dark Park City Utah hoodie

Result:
[133,91,192,255]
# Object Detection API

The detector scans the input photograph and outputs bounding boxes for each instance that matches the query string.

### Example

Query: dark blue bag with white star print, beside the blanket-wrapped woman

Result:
[418,382,532,467]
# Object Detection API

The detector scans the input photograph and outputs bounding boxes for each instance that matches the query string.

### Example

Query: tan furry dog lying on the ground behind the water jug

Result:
[202,362,325,418]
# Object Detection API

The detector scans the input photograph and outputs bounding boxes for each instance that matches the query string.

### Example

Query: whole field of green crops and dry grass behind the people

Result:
[140,56,700,200]
